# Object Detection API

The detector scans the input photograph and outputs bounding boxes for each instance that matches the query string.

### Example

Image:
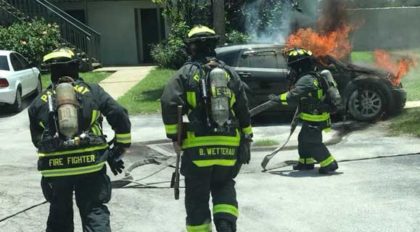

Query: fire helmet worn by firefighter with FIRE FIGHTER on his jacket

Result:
[43,48,80,84]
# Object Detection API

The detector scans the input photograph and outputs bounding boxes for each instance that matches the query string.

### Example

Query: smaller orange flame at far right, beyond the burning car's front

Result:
[374,50,417,86]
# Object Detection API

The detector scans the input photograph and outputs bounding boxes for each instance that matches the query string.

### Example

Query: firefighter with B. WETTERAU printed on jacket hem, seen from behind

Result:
[161,26,252,232]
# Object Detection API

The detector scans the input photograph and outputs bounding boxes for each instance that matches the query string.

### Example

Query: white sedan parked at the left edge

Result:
[0,50,42,112]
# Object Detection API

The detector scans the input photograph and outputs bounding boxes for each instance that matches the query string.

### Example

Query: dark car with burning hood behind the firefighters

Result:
[216,44,406,121]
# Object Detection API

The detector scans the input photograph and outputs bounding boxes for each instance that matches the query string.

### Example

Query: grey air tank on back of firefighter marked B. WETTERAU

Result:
[210,68,231,127]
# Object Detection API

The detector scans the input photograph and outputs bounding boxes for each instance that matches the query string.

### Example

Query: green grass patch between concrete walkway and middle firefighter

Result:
[118,68,176,114]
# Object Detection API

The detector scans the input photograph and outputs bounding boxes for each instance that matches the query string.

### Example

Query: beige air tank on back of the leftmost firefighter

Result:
[55,83,79,138]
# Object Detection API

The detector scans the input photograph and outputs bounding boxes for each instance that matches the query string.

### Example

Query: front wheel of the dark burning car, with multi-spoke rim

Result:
[347,85,387,121]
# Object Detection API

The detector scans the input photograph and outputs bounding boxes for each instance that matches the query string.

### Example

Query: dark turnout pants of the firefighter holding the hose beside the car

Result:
[298,121,334,167]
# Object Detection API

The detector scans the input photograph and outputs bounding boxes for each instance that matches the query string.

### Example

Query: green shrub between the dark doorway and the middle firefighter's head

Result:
[151,22,189,69]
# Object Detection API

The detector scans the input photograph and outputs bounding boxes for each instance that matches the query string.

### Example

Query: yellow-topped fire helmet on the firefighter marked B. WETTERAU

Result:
[185,25,220,56]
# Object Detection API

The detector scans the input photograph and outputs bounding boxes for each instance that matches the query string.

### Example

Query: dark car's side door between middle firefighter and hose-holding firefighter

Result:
[235,48,289,108]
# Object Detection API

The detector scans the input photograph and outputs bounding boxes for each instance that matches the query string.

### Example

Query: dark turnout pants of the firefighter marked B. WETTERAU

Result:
[181,153,240,232]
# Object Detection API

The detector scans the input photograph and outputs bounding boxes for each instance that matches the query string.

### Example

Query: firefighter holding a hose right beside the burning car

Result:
[269,48,338,174]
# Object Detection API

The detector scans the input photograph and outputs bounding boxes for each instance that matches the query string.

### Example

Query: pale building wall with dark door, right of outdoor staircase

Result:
[50,0,166,65]
